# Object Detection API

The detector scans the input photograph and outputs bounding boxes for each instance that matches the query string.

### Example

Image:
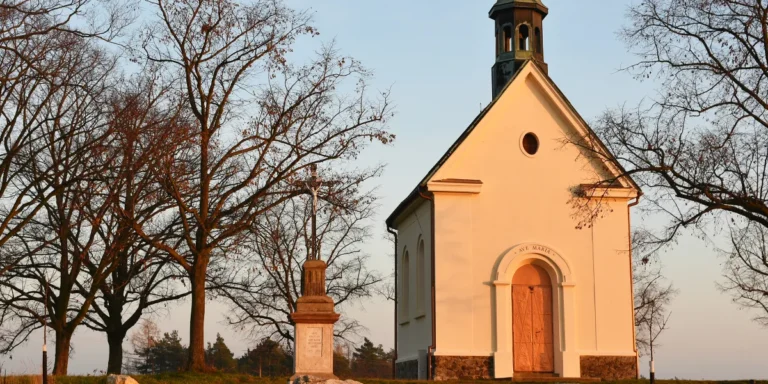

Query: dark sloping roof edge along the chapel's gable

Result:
[386,60,640,227]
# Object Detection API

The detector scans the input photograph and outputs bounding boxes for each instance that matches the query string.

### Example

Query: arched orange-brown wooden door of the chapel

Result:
[512,264,555,372]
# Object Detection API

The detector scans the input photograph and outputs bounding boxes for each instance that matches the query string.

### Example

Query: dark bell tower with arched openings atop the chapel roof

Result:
[489,0,549,98]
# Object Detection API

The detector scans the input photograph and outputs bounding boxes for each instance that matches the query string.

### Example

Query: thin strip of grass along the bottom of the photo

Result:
[0,373,768,384]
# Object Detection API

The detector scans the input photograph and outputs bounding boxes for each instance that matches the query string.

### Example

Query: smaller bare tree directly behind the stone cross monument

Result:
[214,181,383,350]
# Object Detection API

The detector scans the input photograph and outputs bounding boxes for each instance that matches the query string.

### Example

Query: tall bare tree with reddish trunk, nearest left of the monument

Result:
[134,0,392,371]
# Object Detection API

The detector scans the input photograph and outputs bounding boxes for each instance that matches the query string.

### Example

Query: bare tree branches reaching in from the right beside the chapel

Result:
[574,0,768,324]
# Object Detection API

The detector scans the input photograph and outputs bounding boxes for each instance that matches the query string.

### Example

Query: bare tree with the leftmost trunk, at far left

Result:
[0,38,122,374]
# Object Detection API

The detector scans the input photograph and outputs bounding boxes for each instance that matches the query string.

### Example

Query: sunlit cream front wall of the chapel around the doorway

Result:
[431,68,634,372]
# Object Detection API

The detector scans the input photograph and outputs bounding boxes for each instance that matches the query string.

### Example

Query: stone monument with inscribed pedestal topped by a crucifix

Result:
[291,167,339,381]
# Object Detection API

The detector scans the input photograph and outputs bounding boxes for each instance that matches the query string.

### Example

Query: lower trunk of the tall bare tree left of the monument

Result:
[187,256,207,372]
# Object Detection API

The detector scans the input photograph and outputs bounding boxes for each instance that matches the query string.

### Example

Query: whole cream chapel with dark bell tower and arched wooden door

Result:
[387,0,640,380]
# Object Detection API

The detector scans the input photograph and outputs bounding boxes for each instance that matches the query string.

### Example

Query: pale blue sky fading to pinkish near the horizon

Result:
[0,0,768,379]
